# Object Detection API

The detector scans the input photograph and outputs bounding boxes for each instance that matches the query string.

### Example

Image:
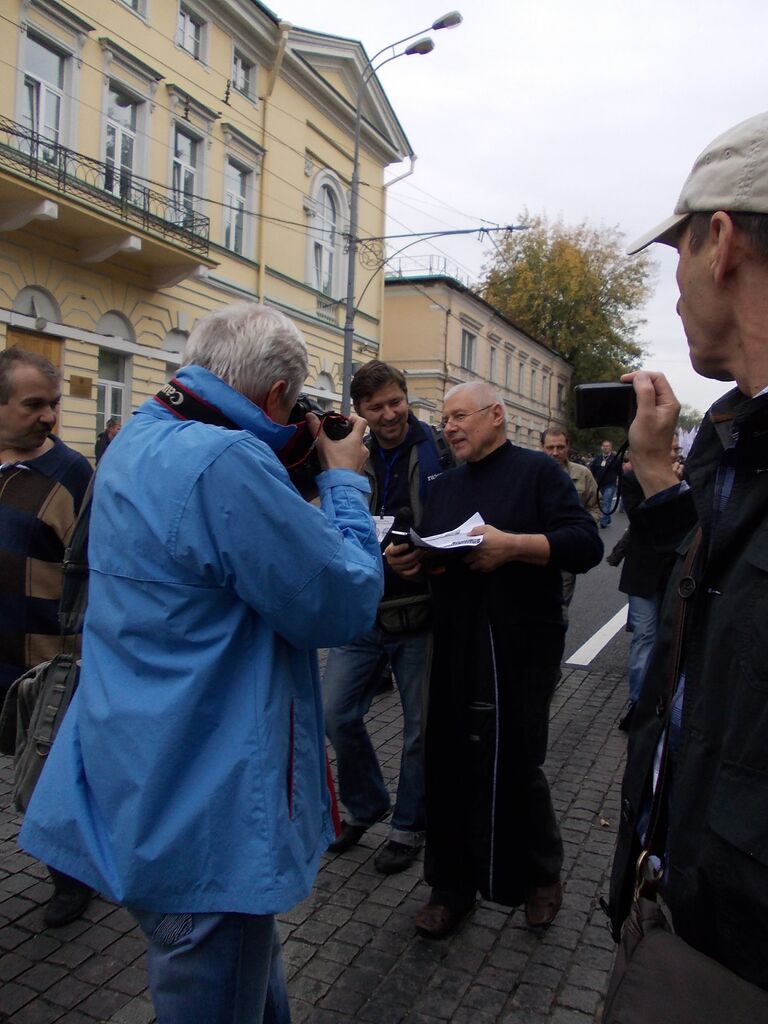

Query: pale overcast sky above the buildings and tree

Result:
[280,0,768,412]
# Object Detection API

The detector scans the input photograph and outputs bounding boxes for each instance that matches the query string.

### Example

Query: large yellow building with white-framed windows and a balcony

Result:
[0,0,413,456]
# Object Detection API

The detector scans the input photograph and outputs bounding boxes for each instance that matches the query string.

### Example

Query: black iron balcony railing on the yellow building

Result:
[0,117,210,256]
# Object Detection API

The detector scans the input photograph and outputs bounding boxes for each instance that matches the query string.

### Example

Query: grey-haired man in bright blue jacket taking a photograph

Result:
[22,303,382,1024]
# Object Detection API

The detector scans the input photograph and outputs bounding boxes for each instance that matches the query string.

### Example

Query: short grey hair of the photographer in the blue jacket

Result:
[184,302,308,404]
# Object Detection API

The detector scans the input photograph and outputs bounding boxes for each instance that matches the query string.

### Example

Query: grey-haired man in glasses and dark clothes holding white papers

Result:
[386,383,602,938]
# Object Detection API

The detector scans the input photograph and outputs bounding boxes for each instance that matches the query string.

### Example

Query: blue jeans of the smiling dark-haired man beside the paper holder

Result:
[323,626,432,842]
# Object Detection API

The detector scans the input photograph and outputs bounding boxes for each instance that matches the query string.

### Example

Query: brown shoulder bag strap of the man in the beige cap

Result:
[636,526,701,895]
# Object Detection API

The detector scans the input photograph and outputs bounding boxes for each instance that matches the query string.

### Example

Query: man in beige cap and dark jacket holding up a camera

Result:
[610,113,768,999]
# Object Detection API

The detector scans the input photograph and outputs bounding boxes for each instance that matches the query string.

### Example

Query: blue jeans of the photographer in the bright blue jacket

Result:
[128,907,291,1024]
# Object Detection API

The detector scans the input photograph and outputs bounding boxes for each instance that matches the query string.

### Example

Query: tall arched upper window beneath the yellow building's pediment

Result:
[305,170,347,299]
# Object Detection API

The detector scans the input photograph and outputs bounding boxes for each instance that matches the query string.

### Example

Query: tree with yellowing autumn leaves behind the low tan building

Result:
[480,211,655,447]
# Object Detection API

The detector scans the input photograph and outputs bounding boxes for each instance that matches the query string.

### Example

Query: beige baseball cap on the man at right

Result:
[627,111,768,256]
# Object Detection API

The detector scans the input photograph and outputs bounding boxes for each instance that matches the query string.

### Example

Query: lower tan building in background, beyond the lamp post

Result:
[382,274,573,449]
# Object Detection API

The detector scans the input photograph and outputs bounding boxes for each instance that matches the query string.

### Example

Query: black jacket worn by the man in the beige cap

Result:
[610,391,768,988]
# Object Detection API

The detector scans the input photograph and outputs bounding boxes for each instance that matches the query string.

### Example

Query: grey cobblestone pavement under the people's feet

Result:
[0,669,626,1024]
